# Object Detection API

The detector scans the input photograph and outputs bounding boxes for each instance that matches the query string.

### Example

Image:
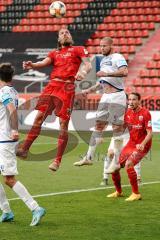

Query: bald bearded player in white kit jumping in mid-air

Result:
[74,37,128,173]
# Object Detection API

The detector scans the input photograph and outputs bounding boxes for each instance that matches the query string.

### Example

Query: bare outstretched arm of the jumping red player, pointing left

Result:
[23,57,52,70]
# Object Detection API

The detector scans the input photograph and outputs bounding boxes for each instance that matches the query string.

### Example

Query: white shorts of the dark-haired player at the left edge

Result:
[0,142,18,176]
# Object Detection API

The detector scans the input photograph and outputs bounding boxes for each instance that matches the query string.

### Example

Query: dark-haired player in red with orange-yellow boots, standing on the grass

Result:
[107,93,152,201]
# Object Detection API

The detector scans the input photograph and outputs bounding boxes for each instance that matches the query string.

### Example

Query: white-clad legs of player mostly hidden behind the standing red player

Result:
[100,131,141,186]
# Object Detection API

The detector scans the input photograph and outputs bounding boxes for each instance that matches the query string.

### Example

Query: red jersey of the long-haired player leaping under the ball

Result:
[48,46,88,81]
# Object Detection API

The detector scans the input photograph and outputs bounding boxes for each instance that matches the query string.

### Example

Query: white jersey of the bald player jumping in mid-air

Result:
[99,53,128,90]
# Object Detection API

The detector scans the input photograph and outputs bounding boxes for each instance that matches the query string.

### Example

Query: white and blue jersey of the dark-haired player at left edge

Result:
[0,86,18,143]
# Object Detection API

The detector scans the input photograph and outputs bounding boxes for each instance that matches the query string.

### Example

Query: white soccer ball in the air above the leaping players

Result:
[49,1,66,18]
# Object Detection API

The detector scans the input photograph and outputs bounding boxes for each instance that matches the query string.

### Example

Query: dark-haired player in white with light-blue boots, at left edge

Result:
[0,63,45,226]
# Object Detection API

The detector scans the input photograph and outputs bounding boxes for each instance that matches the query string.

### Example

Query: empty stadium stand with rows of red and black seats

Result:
[0,0,160,100]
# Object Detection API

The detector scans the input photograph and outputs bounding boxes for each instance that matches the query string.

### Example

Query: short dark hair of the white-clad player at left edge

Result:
[0,63,15,82]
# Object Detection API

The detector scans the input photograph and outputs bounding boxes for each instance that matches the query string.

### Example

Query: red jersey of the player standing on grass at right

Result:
[124,108,152,147]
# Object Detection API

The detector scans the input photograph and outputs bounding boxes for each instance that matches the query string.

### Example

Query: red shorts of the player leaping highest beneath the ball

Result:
[35,81,75,120]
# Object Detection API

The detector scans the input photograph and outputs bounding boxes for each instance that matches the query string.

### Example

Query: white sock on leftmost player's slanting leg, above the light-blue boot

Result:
[12,181,39,211]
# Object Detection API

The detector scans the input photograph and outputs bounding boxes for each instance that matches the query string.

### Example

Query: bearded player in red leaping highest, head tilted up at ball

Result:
[17,28,91,171]
